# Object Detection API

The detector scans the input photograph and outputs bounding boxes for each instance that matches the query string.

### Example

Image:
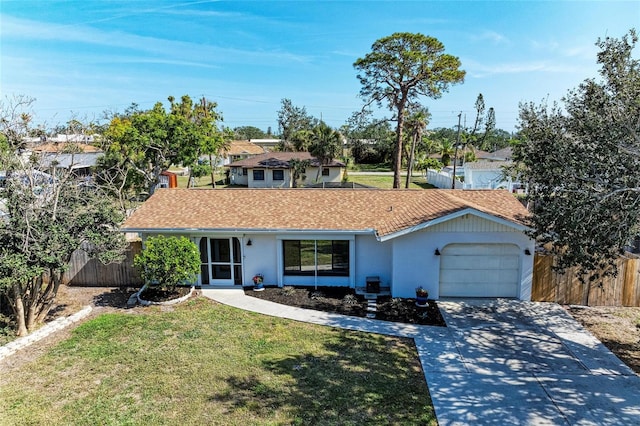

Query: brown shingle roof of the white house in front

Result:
[122,189,527,237]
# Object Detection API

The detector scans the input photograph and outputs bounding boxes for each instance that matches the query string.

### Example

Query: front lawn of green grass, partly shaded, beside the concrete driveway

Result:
[0,298,436,425]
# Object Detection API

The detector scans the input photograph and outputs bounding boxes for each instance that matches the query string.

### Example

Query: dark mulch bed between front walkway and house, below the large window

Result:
[245,286,446,327]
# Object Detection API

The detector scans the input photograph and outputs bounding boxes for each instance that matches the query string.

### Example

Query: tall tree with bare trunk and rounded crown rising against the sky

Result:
[353,33,465,188]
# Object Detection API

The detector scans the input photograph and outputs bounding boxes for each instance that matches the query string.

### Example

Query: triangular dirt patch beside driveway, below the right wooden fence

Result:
[566,306,640,374]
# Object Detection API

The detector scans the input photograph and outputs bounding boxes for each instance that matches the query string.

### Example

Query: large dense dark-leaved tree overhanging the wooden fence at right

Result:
[514,30,640,280]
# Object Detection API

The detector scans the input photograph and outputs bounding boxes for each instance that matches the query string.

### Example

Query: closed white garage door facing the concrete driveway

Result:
[440,244,520,297]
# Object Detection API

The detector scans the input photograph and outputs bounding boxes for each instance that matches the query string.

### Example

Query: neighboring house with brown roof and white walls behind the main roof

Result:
[227,152,346,188]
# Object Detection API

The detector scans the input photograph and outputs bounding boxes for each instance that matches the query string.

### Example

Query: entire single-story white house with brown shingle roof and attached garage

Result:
[122,188,534,300]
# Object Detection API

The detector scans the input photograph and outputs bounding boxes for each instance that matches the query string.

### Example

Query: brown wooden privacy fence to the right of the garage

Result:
[531,254,640,306]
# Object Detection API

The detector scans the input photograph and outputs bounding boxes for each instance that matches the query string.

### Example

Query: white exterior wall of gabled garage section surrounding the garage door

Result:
[391,215,534,300]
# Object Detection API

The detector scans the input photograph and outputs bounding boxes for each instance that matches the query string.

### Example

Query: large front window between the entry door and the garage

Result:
[282,240,349,277]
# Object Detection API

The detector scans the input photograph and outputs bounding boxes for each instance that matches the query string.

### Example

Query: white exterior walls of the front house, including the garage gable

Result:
[145,214,534,300]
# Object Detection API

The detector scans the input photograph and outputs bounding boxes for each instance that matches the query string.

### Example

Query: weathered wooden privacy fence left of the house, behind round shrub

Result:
[63,241,143,287]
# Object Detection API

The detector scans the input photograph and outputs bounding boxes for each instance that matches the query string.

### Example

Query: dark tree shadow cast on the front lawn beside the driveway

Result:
[212,330,435,424]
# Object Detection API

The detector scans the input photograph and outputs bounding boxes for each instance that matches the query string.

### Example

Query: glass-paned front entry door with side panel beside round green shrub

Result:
[200,237,242,285]
